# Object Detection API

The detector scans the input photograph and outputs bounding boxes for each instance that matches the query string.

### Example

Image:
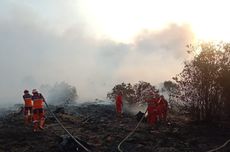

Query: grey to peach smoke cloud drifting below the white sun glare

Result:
[0,1,193,106]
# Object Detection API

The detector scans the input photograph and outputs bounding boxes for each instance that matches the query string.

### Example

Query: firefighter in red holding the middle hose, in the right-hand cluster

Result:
[146,96,157,125]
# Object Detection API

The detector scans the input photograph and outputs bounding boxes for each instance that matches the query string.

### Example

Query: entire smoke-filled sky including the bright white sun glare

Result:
[0,0,230,105]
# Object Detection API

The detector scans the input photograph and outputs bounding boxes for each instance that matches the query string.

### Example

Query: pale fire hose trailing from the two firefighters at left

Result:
[45,102,90,152]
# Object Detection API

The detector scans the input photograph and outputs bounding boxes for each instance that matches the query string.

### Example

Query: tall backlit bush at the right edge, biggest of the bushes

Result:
[173,42,230,121]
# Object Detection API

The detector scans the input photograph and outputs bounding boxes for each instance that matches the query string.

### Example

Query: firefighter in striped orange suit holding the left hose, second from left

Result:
[32,89,45,132]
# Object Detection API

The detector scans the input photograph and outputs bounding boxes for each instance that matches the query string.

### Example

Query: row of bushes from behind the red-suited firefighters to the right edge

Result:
[107,42,230,121]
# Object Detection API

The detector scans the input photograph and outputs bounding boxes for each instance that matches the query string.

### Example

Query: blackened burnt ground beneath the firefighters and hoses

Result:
[0,104,230,152]
